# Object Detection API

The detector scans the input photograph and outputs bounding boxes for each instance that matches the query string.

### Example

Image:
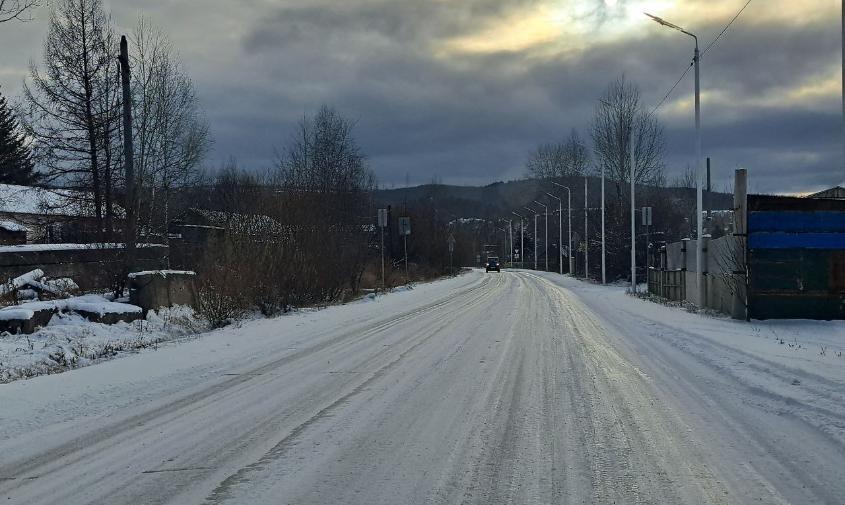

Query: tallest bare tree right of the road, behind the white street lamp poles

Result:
[592,77,664,207]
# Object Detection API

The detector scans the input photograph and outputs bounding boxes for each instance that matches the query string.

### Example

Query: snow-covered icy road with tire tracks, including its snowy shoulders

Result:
[0,272,845,505]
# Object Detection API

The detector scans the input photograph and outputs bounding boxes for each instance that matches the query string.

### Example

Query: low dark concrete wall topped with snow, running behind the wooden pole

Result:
[0,244,168,290]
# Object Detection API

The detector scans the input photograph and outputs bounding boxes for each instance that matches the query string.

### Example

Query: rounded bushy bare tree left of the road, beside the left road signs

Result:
[278,106,375,300]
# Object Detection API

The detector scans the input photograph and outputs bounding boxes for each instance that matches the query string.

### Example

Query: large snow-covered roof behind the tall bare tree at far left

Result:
[0,184,115,217]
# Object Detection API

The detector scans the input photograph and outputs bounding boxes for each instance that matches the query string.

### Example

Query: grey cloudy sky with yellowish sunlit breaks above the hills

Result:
[0,0,845,193]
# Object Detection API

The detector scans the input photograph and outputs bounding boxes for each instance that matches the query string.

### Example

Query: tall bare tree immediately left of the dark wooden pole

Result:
[22,0,120,239]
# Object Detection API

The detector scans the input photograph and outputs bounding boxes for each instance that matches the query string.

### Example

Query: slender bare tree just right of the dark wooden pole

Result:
[132,18,210,239]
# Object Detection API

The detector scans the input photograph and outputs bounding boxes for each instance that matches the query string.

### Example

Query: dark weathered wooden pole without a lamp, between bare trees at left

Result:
[118,35,137,276]
